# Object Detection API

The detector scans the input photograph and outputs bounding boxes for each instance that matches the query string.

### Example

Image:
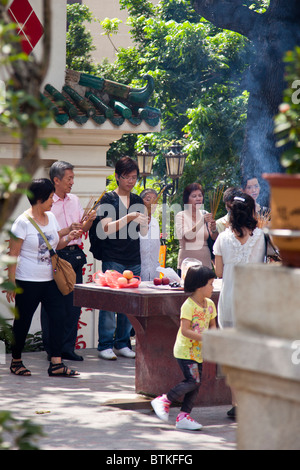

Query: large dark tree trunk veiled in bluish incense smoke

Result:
[194,0,300,205]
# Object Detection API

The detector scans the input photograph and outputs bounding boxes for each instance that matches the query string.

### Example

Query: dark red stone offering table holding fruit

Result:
[74,280,231,406]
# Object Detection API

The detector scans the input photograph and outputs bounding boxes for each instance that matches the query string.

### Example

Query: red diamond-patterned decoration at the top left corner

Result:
[8,0,44,54]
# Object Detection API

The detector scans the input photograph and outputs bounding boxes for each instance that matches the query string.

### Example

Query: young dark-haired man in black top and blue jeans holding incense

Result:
[98,156,148,360]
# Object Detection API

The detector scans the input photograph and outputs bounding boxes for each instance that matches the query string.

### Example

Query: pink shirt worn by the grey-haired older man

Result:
[51,193,83,246]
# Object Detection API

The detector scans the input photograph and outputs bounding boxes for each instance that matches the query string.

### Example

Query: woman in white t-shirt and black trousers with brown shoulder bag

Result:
[6,178,81,376]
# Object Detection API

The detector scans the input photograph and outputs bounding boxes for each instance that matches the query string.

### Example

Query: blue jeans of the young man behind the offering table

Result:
[98,261,141,351]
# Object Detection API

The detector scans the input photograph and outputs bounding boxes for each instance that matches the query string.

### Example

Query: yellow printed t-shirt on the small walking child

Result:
[174,297,217,363]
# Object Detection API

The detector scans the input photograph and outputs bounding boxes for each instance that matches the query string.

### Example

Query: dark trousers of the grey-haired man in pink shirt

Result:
[41,246,86,354]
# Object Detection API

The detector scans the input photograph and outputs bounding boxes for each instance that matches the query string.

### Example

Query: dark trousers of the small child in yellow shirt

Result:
[167,359,202,413]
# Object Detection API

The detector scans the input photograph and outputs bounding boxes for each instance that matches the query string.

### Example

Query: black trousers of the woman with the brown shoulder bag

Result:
[12,280,64,359]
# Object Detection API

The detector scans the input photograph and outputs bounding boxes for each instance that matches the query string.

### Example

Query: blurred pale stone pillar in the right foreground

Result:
[203,265,300,450]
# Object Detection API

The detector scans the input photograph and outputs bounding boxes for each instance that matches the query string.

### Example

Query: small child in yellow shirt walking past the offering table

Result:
[151,266,217,431]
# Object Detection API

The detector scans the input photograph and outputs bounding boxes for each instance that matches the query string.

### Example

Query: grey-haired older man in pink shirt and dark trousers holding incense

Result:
[41,161,96,361]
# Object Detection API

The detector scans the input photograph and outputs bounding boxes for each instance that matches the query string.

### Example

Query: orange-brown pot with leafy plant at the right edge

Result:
[263,47,300,267]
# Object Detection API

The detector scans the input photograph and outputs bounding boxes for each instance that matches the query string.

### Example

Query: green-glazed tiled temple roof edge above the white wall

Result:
[41,70,161,127]
